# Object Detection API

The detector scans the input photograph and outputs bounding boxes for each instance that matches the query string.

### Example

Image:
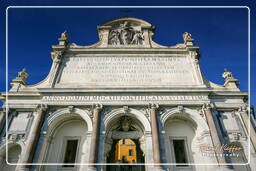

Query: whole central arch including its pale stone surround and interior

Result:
[104,108,151,170]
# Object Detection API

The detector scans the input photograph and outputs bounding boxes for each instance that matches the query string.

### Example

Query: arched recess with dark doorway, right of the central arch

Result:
[164,115,197,170]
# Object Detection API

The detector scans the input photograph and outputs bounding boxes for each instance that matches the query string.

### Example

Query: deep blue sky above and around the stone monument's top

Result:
[0,0,256,106]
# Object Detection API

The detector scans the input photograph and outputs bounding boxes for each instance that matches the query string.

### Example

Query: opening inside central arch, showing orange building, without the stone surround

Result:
[105,115,145,171]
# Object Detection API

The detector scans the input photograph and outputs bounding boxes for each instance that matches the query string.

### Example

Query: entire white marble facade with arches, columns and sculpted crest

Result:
[0,18,256,171]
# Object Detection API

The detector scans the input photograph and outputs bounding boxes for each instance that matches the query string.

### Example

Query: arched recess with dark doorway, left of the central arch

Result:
[44,116,89,171]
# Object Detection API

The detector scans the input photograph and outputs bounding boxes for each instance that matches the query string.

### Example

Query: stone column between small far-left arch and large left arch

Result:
[20,105,46,171]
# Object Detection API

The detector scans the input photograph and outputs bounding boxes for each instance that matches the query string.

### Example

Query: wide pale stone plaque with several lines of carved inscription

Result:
[59,55,195,87]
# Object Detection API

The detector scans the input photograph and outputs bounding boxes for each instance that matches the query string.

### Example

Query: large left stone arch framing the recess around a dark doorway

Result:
[36,108,93,170]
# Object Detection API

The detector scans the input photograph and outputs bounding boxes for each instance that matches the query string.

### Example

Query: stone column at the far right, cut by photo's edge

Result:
[239,108,256,151]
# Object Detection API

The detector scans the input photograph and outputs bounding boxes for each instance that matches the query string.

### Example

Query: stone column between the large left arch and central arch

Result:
[88,104,102,170]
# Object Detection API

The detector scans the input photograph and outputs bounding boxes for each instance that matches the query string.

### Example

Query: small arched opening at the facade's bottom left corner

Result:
[0,144,21,171]
